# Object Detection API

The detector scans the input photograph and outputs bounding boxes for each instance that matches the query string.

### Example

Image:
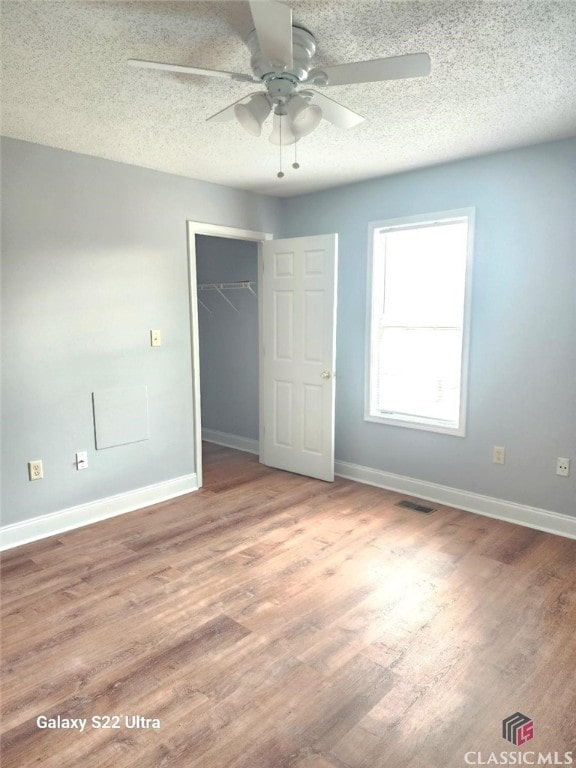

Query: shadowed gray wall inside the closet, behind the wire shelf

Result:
[196,235,259,440]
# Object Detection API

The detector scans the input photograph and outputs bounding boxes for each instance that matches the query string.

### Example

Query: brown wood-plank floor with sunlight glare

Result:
[2,445,576,768]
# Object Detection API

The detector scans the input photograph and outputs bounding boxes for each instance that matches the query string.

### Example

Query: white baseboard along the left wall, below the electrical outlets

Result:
[0,473,198,550]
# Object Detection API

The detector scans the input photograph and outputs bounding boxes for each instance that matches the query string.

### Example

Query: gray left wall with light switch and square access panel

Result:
[2,139,279,525]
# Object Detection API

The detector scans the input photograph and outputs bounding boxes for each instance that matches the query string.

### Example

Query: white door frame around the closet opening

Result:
[186,221,274,488]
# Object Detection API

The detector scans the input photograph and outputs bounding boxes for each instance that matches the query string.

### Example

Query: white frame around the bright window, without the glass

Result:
[364,207,476,437]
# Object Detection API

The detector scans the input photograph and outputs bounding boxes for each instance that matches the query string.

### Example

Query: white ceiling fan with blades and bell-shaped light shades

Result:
[128,0,430,154]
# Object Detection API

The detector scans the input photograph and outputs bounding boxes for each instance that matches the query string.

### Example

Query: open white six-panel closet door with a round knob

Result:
[260,234,338,480]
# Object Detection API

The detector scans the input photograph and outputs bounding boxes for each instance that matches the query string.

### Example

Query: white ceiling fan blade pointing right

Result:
[308,53,430,85]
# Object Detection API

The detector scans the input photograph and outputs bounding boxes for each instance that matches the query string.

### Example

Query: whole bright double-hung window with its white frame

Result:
[365,208,474,435]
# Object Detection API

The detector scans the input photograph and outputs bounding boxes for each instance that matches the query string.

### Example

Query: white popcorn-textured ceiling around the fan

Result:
[0,0,576,195]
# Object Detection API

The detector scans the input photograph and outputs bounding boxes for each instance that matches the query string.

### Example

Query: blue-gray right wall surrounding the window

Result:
[280,140,576,515]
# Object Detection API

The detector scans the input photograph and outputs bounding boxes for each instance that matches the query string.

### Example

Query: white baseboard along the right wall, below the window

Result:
[334,461,576,539]
